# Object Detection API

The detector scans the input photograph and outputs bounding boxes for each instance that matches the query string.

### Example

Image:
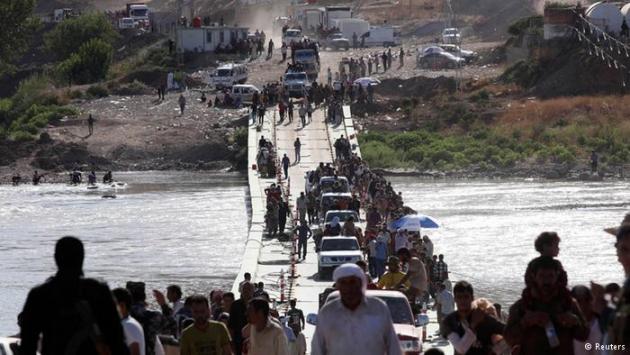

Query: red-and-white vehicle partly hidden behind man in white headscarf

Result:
[306,288,429,355]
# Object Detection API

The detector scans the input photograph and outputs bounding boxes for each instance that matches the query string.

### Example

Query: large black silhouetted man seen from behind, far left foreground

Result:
[20,236,129,355]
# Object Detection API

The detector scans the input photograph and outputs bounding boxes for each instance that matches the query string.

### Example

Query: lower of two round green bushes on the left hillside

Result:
[57,38,114,85]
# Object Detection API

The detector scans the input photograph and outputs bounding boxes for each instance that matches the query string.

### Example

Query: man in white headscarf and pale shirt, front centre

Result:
[311,264,402,355]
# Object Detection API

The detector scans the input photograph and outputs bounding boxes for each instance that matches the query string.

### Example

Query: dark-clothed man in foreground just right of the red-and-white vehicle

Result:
[442,281,505,355]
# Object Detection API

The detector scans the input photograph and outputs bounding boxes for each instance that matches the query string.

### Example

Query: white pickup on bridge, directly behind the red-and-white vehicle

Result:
[317,236,363,280]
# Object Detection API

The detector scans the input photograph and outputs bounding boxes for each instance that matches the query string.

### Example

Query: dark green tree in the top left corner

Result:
[0,0,39,76]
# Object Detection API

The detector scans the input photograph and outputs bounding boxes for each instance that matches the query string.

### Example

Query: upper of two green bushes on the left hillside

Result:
[44,13,118,60]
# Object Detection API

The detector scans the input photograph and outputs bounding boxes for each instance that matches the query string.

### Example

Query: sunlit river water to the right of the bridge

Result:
[390,177,630,310]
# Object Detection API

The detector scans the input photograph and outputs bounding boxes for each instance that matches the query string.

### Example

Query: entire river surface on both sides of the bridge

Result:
[0,177,630,335]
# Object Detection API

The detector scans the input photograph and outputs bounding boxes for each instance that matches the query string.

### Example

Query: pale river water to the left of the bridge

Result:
[0,172,248,336]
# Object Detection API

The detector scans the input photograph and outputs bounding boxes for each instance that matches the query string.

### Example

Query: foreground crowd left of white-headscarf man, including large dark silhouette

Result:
[16,237,306,355]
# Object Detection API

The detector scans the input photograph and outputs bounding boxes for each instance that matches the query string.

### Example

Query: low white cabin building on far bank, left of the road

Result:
[176,26,249,53]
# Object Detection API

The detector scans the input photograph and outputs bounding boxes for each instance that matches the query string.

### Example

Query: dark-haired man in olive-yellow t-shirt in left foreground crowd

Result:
[180,295,233,355]
